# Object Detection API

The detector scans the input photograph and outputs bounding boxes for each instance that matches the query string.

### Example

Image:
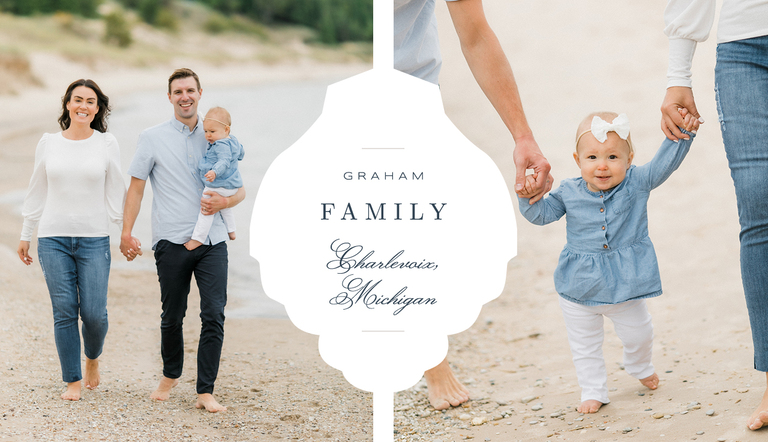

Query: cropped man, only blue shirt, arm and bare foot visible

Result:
[394,0,553,410]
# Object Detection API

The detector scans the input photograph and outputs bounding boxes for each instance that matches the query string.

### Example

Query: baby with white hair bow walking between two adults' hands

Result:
[519,109,698,413]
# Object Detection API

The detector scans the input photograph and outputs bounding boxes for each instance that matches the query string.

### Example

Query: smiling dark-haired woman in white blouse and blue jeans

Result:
[17,80,125,401]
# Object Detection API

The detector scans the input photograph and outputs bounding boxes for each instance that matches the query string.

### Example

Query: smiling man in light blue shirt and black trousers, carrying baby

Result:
[120,69,245,413]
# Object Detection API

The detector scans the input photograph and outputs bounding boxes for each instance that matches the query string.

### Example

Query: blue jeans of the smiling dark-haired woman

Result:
[37,236,111,383]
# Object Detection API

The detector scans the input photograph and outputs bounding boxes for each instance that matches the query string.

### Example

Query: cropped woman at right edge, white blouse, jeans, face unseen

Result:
[661,0,768,430]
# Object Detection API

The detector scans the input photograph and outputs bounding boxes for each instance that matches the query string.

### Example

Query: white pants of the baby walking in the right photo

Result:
[559,296,654,404]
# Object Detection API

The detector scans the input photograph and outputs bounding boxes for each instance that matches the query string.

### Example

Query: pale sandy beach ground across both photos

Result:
[0,0,768,442]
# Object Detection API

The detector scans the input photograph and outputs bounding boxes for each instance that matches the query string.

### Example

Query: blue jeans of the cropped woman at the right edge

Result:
[715,35,768,372]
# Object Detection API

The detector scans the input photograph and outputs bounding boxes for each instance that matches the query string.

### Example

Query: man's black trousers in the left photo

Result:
[155,240,229,394]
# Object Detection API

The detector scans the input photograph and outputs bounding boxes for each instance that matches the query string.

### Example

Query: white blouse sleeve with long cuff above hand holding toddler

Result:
[664,0,715,87]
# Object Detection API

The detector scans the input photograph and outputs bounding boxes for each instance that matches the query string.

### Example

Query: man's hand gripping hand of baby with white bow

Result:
[513,135,554,204]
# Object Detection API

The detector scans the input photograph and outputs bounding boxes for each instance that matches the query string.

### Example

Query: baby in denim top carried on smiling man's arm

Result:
[184,107,245,250]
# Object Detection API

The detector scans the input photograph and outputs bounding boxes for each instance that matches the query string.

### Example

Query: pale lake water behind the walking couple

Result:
[110,78,342,318]
